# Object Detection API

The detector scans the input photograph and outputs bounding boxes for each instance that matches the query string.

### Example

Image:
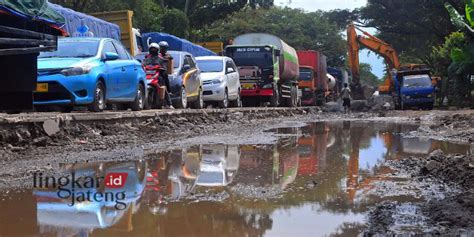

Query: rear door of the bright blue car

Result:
[114,41,138,101]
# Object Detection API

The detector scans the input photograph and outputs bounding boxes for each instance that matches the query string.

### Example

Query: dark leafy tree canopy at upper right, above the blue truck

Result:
[360,0,464,64]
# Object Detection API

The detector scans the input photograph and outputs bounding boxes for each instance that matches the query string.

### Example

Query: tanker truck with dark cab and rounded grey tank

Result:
[225,33,301,107]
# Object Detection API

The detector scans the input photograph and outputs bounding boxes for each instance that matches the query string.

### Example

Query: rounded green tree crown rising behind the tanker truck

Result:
[198,7,346,66]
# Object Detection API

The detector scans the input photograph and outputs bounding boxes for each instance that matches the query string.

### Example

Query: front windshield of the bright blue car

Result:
[39,40,99,58]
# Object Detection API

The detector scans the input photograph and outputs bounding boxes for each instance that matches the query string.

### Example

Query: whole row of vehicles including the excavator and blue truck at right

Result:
[0,0,434,112]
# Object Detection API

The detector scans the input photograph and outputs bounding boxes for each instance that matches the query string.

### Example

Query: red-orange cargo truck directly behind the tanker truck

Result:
[297,50,329,106]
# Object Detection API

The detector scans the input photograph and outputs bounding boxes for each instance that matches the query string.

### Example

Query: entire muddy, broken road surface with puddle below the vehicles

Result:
[0,109,474,237]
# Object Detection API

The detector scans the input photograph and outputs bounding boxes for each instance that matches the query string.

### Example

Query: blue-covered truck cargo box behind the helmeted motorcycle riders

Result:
[142,32,216,57]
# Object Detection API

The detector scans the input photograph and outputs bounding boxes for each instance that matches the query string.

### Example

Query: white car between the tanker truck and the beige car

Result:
[196,56,242,108]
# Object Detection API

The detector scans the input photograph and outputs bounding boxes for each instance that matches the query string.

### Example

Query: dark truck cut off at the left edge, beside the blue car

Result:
[0,0,66,113]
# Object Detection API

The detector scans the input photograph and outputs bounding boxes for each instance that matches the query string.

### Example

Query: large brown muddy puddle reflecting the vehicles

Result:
[0,122,471,237]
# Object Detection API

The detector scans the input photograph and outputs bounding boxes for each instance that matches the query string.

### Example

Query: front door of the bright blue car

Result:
[101,40,124,100]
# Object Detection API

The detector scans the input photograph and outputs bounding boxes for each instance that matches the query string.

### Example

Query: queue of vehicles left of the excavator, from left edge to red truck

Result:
[0,2,348,112]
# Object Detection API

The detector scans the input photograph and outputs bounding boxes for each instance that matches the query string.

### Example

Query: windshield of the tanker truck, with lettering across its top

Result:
[227,47,273,67]
